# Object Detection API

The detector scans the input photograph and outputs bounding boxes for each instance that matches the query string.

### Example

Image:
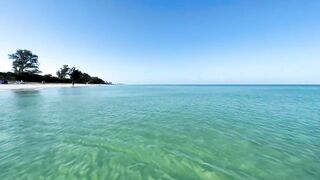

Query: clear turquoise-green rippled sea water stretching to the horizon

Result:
[0,86,320,180]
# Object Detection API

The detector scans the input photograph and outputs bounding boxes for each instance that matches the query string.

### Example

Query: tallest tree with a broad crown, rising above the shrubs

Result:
[9,49,41,74]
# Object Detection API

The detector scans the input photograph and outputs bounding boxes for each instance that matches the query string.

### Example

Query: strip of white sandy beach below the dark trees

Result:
[0,83,98,91]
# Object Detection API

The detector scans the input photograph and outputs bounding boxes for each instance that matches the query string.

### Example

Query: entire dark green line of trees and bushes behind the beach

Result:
[0,49,111,84]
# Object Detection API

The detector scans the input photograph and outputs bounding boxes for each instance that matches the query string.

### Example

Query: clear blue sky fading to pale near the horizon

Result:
[0,0,320,84]
